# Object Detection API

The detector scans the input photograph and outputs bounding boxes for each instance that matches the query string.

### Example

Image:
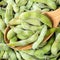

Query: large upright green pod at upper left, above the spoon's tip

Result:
[5,4,13,24]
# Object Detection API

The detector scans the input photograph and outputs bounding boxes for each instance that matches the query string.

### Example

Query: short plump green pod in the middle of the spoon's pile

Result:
[14,27,34,39]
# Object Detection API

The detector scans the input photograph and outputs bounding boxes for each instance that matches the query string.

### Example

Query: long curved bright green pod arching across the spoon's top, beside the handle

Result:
[20,11,52,27]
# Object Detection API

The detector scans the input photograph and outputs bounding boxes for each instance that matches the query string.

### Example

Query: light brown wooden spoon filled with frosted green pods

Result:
[4,8,60,50]
